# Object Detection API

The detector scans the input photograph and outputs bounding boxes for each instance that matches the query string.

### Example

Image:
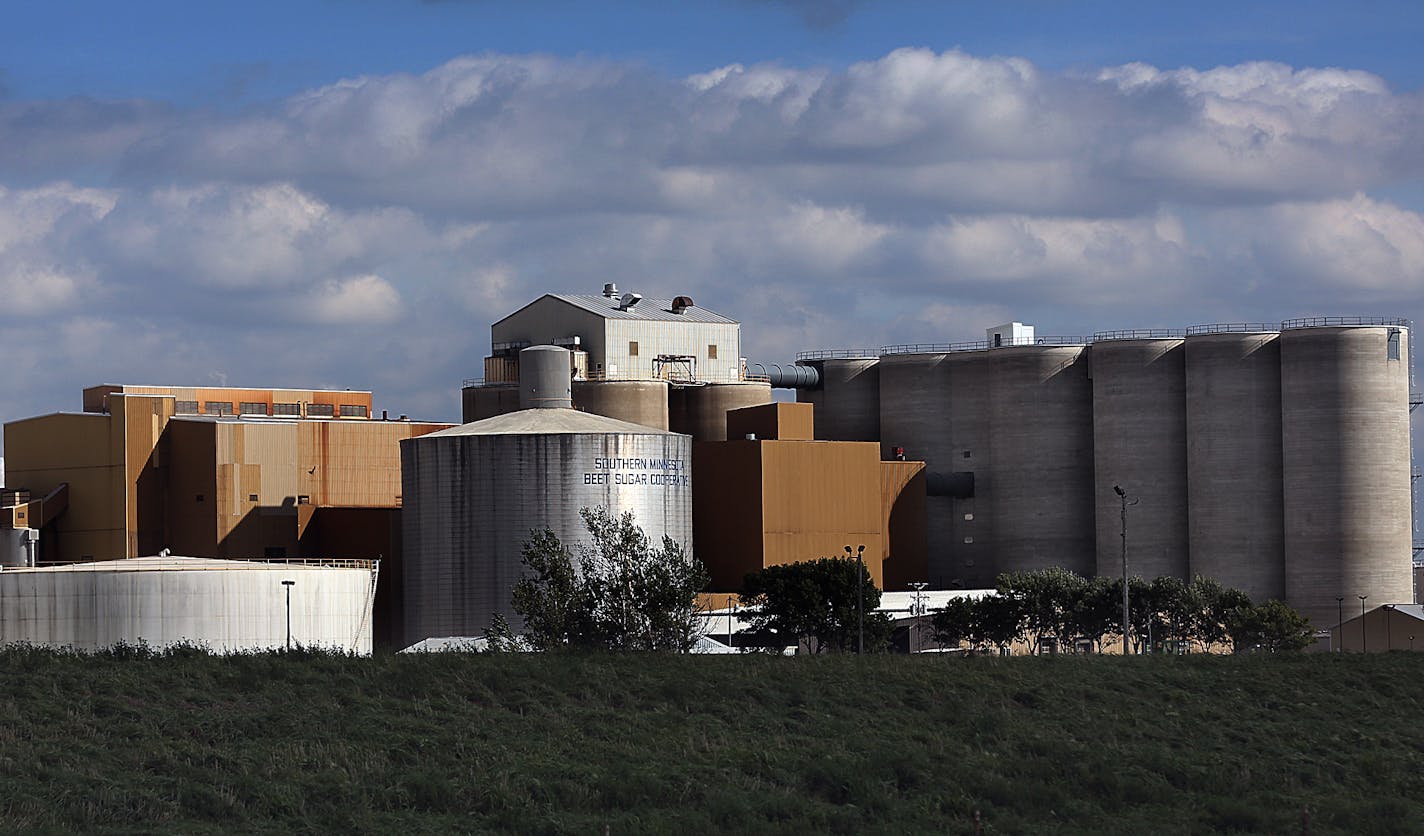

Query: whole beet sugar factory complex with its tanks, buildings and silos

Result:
[0,285,1424,652]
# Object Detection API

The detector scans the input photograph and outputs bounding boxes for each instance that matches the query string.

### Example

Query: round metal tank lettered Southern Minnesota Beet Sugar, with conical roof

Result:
[400,409,692,644]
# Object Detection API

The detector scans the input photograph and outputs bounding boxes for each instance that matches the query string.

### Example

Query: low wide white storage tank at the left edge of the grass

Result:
[0,555,377,655]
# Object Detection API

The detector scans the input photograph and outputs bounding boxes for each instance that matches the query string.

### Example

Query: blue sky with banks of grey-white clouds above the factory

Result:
[0,0,1424,420]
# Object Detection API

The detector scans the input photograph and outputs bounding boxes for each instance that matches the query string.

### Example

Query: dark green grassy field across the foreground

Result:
[0,649,1424,833]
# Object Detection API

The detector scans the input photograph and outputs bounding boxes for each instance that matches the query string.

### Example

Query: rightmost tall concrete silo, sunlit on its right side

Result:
[1280,320,1414,627]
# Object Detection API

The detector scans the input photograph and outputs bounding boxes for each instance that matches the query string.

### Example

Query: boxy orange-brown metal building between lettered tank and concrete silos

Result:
[692,403,928,594]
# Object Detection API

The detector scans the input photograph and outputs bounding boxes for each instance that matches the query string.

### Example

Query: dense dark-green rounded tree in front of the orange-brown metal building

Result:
[742,557,890,654]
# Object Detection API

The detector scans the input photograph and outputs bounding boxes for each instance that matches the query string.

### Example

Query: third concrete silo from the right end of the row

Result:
[1089,335,1190,581]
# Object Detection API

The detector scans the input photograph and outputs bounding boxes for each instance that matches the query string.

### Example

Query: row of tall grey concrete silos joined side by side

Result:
[800,319,1411,624]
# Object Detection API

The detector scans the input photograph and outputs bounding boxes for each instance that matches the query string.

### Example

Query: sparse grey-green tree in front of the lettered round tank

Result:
[504,508,706,651]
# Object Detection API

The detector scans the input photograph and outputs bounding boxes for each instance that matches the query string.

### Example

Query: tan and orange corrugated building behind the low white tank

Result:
[4,386,450,563]
